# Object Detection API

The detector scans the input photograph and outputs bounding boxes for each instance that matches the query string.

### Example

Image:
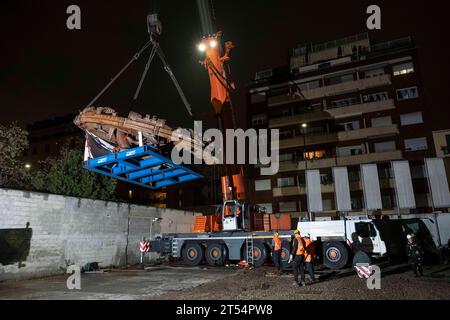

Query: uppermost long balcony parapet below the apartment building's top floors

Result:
[267,74,392,107]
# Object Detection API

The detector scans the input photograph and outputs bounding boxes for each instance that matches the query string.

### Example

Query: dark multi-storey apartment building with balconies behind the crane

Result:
[247,33,440,219]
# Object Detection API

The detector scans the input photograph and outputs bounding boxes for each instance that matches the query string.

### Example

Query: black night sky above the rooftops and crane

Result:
[0,0,450,128]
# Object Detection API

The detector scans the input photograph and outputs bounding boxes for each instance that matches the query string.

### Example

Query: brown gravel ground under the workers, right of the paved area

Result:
[152,266,450,300]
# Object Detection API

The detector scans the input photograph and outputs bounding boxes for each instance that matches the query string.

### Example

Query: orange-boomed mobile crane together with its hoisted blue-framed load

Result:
[75,0,440,269]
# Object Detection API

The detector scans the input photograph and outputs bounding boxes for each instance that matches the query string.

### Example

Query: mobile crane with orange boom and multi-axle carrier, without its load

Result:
[150,0,440,269]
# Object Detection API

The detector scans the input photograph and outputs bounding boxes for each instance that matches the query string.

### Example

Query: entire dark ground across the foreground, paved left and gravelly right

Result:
[0,266,450,300]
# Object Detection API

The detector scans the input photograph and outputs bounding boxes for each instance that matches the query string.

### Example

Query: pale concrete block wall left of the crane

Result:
[0,189,195,281]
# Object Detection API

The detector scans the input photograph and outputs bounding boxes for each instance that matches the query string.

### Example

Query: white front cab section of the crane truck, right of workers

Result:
[297,218,438,269]
